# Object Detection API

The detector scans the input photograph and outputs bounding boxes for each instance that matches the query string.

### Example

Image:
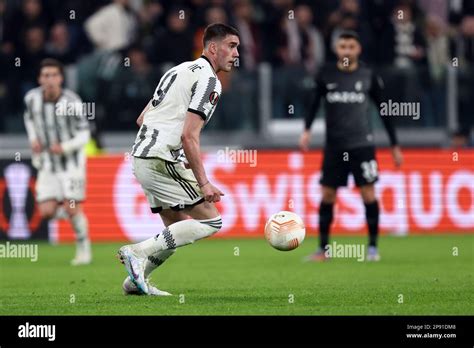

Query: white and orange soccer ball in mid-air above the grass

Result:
[265,211,306,251]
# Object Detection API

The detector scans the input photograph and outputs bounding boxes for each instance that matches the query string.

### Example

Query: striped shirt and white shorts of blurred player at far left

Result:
[24,87,90,202]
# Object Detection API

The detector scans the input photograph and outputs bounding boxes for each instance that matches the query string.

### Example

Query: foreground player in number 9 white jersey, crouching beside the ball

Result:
[118,24,240,295]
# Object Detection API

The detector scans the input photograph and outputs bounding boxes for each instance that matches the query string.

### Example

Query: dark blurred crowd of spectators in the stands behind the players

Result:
[0,0,474,143]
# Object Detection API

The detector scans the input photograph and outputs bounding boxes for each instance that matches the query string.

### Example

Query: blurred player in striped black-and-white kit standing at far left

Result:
[24,58,92,265]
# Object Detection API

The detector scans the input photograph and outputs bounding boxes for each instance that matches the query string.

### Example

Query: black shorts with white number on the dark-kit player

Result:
[319,146,379,188]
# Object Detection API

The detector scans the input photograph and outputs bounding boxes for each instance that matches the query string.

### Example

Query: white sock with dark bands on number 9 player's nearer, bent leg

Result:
[133,216,222,257]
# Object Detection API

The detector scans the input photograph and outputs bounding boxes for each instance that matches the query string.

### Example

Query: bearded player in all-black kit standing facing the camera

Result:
[299,32,402,261]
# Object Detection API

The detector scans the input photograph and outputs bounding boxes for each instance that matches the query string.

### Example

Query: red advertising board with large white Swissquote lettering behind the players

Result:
[55,149,474,241]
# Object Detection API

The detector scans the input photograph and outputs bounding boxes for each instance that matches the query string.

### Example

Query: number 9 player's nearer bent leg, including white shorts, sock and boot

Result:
[119,158,222,293]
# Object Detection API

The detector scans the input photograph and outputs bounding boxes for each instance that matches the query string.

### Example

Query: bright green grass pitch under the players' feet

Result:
[0,235,474,315]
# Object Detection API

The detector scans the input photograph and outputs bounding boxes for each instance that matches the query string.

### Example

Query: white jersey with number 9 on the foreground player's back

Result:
[132,56,222,162]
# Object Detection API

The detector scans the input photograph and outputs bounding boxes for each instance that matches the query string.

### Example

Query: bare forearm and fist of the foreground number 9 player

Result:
[181,112,224,202]
